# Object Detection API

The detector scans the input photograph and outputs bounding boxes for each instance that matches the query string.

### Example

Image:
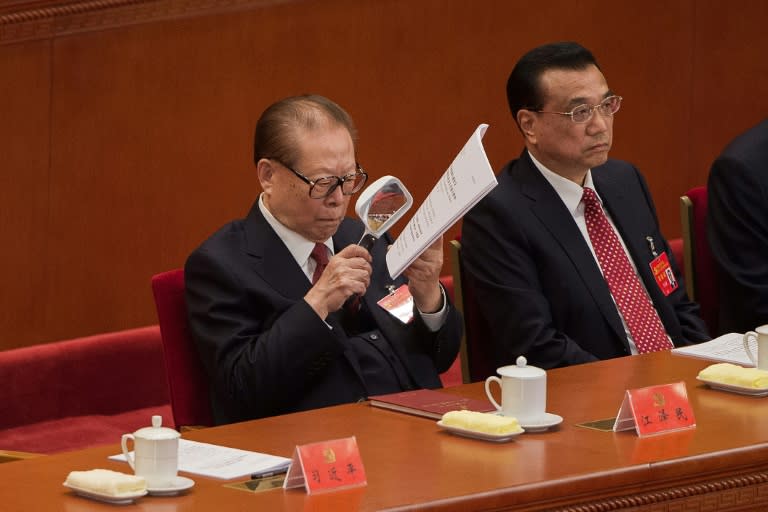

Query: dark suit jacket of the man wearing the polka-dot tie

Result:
[462,152,708,368]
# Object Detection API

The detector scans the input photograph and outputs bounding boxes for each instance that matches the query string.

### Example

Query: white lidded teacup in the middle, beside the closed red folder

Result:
[485,356,547,425]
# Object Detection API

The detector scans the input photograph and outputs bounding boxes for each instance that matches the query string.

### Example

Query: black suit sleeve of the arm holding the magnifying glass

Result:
[185,246,342,420]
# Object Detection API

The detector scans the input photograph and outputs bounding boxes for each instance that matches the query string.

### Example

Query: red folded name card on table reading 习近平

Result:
[283,436,368,494]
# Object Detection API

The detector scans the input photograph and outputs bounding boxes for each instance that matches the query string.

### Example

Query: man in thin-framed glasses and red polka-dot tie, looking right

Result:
[462,43,708,368]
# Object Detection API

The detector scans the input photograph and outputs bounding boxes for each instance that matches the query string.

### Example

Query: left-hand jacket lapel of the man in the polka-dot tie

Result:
[518,152,626,340]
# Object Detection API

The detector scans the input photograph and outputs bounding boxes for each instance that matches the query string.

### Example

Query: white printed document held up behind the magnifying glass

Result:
[387,124,496,279]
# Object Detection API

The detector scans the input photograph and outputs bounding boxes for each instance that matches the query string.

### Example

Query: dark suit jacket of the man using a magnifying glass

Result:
[185,202,462,423]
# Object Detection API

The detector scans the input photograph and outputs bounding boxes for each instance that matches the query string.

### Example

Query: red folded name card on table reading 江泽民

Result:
[613,381,696,437]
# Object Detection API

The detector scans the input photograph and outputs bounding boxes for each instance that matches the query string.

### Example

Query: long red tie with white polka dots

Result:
[581,188,672,354]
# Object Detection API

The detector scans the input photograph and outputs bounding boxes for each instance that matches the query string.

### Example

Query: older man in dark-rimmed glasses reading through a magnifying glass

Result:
[185,96,461,423]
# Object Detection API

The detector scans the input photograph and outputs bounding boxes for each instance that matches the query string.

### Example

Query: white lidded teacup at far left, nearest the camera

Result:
[120,415,180,489]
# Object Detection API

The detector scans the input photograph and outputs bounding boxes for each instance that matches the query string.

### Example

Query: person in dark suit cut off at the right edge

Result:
[707,119,768,332]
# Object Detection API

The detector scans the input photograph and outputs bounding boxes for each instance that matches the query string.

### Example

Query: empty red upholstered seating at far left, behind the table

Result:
[0,325,171,454]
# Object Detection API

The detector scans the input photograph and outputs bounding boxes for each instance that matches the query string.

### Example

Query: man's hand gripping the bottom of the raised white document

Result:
[403,236,443,313]
